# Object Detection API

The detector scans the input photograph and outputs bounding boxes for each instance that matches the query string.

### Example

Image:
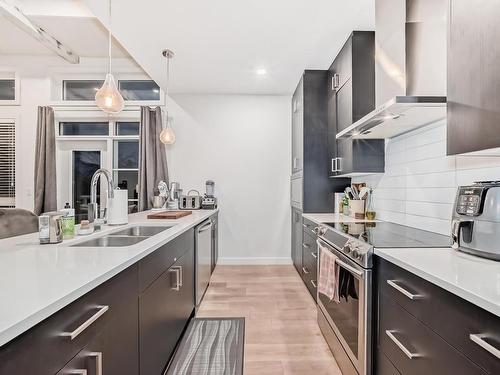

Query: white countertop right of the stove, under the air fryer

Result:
[375,248,500,317]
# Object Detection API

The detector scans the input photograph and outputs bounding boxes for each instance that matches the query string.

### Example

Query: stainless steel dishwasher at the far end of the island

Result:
[195,219,213,307]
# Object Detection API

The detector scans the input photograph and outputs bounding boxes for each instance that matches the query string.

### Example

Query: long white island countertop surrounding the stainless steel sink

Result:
[0,210,217,346]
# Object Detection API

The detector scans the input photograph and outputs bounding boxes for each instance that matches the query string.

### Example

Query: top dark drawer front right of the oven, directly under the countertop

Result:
[378,259,500,374]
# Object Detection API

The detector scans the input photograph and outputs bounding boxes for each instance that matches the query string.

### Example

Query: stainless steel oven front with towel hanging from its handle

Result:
[318,238,372,375]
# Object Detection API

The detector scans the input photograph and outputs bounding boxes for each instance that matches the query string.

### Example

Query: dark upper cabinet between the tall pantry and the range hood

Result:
[326,31,385,177]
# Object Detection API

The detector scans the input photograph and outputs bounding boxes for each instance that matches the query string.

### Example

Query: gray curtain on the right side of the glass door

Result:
[139,107,169,211]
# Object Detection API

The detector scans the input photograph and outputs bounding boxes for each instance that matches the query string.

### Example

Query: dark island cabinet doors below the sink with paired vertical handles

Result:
[139,248,194,375]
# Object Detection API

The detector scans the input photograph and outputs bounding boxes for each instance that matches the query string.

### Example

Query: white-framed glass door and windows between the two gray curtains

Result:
[56,119,139,222]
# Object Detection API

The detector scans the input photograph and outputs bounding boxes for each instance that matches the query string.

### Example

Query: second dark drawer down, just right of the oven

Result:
[378,295,485,375]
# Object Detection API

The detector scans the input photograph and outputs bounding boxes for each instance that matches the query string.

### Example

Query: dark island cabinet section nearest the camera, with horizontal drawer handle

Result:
[0,265,139,375]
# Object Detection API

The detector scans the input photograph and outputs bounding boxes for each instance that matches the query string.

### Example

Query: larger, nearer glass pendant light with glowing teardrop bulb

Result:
[95,0,125,113]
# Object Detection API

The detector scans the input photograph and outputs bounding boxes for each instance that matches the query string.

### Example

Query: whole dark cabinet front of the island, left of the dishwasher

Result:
[0,220,207,375]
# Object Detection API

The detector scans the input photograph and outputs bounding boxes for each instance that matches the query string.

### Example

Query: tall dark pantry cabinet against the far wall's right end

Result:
[290,70,350,273]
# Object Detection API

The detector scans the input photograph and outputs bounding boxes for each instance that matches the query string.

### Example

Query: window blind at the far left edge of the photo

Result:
[0,121,16,207]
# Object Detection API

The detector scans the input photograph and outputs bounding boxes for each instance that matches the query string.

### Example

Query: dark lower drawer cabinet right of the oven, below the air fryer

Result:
[375,257,500,375]
